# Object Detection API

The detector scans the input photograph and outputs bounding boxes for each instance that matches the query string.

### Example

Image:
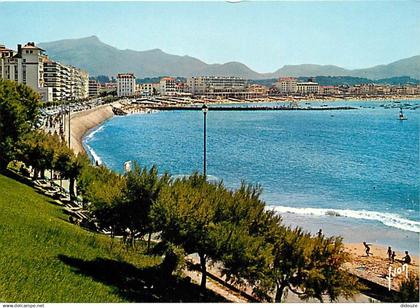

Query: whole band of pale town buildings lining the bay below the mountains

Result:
[0,42,420,103]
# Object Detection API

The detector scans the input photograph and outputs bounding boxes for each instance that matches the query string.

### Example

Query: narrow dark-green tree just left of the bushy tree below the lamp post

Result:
[122,163,170,251]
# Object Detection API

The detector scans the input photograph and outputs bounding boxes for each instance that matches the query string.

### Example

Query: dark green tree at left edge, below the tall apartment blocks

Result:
[0,79,41,170]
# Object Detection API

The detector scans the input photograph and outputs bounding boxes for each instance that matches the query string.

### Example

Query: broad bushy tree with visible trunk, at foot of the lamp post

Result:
[150,173,229,289]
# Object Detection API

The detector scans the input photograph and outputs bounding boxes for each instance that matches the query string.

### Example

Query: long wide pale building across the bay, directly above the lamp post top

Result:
[187,76,247,97]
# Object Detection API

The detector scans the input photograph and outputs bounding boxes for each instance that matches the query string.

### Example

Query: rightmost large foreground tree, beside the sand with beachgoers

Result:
[261,226,360,302]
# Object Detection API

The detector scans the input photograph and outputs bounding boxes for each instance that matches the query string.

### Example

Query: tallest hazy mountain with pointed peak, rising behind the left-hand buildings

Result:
[39,36,259,78]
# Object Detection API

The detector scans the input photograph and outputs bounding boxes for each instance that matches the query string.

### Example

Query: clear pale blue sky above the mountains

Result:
[0,0,420,73]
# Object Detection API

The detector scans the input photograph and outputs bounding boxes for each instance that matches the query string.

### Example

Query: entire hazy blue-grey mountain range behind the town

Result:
[39,36,420,79]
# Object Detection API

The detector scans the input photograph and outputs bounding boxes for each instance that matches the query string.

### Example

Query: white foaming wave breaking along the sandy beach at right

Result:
[270,206,420,233]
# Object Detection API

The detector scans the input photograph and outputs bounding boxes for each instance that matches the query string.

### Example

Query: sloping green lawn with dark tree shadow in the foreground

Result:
[0,174,228,302]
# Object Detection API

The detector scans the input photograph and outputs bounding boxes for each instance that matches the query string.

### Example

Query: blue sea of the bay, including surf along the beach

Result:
[84,101,420,255]
